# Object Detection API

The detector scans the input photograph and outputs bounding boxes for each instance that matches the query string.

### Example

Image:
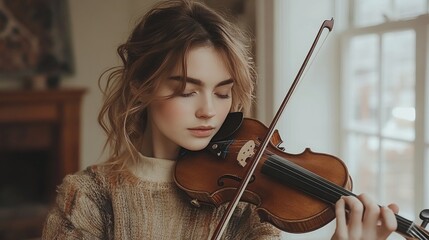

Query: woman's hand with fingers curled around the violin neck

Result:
[332,194,399,240]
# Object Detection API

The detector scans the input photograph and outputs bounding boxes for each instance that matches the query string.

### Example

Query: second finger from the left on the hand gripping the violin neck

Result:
[343,196,363,239]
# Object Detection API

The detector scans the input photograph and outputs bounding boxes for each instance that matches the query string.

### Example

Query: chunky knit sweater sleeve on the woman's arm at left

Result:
[42,168,113,240]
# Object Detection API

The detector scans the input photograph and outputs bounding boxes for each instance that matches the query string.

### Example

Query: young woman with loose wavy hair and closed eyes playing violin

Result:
[43,0,396,239]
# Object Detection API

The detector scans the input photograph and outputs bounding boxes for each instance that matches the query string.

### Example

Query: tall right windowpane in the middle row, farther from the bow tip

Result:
[381,31,415,141]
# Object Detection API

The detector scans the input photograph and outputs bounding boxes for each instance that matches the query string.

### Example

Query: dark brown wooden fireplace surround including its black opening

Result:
[0,89,85,239]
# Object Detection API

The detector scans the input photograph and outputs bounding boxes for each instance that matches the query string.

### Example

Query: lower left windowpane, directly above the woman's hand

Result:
[346,134,379,198]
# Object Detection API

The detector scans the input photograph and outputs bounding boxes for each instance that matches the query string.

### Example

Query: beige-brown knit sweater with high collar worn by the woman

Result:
[42,156,279,240]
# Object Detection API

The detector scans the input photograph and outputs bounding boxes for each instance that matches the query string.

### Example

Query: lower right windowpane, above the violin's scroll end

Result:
[382,140,415,219]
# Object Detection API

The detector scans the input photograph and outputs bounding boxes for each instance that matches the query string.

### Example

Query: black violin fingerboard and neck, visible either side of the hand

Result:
[261,155,429,240]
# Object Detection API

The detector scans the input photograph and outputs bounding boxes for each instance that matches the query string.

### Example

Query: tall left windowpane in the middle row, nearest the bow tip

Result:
[345,35,379,133]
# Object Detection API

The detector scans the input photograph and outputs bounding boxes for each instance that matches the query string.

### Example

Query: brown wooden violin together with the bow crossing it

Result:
[174,19,429,240]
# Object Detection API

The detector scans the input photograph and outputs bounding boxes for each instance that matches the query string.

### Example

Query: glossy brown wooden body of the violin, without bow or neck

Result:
[175,119,352,233]
